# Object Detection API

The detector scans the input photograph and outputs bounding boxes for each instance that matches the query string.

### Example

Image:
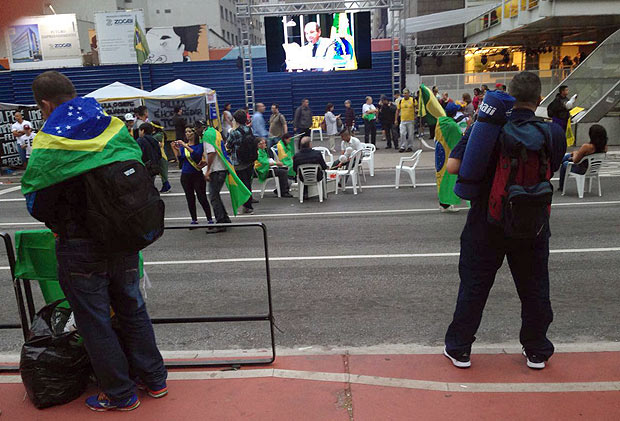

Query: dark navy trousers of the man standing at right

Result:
[445,203,554,359]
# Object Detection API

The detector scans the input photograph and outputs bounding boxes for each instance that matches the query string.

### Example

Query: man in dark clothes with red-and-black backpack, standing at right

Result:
[444,72,566,369]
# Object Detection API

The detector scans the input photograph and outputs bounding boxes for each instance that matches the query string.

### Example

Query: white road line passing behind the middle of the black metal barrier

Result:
[0,247,620,270]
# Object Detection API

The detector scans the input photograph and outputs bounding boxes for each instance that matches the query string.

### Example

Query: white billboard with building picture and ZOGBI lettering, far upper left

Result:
[5,14,82,70]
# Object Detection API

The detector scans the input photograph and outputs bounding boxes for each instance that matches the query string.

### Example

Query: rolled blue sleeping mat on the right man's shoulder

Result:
[454,91,515,200]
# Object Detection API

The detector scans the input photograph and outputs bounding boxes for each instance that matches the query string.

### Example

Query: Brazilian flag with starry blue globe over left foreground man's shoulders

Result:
[22,97,142,194]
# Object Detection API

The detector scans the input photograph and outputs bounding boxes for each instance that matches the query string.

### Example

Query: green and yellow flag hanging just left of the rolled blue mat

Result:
[435,117,461,205]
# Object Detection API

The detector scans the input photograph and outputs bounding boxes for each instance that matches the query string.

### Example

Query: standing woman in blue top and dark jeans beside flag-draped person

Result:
[172,126,213,225]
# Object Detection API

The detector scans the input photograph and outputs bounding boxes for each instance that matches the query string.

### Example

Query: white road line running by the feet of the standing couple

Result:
[0,199,620,227]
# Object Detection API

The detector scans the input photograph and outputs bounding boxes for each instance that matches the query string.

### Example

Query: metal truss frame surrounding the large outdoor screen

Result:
[237,0,404,112]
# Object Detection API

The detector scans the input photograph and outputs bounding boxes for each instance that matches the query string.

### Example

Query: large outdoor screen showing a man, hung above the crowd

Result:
[265,12,372,72]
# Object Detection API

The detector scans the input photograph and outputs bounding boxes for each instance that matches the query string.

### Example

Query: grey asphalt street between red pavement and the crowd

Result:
[0,170,620,352]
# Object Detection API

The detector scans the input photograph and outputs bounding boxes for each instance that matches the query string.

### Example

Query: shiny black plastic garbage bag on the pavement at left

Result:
[19,300,92,408]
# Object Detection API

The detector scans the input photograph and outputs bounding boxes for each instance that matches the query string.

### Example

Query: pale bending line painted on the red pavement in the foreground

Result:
[0,368,620,393]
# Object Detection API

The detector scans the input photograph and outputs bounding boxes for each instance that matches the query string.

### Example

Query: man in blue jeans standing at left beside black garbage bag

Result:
[22,71,168,411]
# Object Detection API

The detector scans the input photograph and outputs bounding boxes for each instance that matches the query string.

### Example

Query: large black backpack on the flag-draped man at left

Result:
[84,160,165,252]
